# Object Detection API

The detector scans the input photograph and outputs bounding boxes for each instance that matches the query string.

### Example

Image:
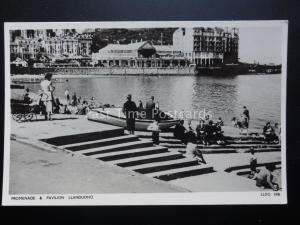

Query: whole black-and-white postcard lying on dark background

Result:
[2,21,288,205]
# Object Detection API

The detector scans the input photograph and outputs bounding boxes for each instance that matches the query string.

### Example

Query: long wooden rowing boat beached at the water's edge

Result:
[87,108,179,131]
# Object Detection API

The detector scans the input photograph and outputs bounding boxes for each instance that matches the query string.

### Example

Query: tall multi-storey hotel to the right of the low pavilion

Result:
[173,28,239,67]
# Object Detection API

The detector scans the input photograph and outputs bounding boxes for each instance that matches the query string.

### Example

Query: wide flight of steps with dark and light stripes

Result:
[42,129,213,181]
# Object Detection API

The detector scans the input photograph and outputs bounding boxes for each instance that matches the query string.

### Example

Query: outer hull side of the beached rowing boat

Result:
[87,109,179,131]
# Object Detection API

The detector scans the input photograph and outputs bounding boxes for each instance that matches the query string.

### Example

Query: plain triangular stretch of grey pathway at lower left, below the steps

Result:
[9,141,188,194]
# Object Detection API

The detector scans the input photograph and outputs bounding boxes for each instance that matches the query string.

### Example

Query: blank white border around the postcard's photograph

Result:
[2,20,288,205]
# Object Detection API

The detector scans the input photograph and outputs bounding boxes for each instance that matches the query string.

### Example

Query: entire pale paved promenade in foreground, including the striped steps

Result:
[11,115,281,193]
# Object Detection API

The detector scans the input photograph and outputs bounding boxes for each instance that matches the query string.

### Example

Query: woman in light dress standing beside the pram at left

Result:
[41,73,55,120]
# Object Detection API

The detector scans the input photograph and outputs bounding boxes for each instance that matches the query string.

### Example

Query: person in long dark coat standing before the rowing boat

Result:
[123,94,137,134]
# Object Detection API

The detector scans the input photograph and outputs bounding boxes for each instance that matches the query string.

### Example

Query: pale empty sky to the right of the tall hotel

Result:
[239,27,283,64]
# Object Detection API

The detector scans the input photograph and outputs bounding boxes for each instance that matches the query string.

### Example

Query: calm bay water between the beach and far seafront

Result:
[26,75,281,128]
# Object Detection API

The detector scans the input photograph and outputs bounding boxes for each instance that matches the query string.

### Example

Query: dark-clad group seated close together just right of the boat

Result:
[173,117,225,145]
